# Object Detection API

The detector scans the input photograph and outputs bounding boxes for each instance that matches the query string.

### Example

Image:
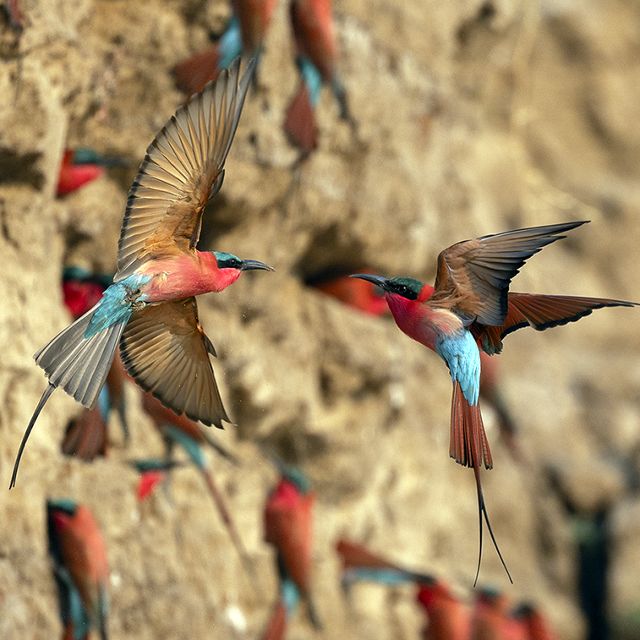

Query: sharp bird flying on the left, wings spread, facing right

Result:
[10,60,272,486]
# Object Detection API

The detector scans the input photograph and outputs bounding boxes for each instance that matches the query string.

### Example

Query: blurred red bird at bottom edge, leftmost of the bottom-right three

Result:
[416,578,471,640]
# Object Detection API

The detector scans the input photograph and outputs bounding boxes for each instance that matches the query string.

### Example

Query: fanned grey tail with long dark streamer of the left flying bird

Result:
[9,303,128,488]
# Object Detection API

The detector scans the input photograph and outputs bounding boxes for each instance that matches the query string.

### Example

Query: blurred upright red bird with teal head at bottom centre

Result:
[264,461,321,629]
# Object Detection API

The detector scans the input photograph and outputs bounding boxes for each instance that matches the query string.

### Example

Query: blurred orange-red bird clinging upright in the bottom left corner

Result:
[47,499,109,640]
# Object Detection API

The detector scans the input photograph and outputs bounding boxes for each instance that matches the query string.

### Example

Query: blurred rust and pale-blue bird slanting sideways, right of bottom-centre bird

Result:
[336,539,432,592]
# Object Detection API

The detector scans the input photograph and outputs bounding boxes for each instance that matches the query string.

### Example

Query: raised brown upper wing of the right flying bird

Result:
[429,221,585,325]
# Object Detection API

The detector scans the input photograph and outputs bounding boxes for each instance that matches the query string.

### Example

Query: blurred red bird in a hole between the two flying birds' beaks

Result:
[305,269,389,316]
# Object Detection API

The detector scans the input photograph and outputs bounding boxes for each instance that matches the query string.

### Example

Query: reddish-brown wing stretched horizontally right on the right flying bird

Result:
[471,293,637,354]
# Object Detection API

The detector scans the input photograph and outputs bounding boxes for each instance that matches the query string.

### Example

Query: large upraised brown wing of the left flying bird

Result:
[114,59,255,281]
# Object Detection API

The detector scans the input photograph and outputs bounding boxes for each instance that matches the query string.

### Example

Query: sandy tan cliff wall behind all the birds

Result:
[0,0,640,640]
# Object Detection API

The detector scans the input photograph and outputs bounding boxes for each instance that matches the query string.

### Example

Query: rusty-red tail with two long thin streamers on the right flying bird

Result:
[449,381,513,587]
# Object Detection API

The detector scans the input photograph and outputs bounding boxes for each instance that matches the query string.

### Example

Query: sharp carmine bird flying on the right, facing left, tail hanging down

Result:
[353,221,635,584]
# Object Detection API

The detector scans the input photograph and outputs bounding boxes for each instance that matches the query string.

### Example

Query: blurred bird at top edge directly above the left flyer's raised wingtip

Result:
[173,0,278,95]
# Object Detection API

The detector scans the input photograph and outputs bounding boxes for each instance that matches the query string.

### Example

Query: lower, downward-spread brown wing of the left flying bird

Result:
[120,298,230,428]
